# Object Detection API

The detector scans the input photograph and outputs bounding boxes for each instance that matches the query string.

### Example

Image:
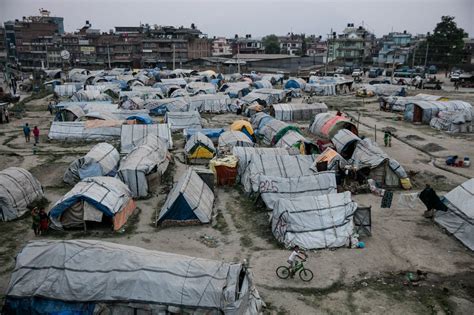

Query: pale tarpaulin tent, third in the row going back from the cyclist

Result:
[240,154,314,192]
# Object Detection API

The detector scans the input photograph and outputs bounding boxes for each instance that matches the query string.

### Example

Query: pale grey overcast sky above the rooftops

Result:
[0,0,474,37]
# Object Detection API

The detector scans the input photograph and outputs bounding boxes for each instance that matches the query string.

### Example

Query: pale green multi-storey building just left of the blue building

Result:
[328,23,375,65]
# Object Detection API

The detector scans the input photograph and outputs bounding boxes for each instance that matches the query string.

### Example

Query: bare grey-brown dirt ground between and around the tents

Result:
[0,82,474,314]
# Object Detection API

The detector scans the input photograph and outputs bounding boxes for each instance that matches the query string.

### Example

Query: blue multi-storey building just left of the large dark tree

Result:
[376,31,412,67]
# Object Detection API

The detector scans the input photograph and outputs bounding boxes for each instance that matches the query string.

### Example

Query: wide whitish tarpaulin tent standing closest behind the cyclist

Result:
[272,191,357,249]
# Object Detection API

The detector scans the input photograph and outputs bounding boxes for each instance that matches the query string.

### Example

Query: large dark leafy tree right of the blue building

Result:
[420,16,467,68]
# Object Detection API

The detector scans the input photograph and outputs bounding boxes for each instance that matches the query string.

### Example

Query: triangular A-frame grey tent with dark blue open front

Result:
[157,168,214,224]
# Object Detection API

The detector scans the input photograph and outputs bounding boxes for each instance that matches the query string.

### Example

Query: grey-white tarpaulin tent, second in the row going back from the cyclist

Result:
[258,172,337,209]
